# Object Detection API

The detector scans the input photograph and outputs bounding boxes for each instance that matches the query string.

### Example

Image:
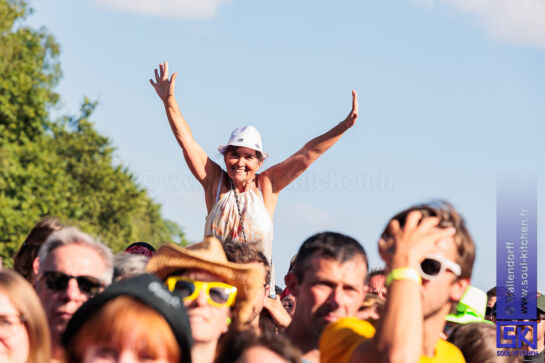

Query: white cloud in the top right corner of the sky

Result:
[417,0,545,49]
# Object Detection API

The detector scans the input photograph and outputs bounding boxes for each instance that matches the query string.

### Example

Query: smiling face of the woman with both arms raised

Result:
[225,147,263,184]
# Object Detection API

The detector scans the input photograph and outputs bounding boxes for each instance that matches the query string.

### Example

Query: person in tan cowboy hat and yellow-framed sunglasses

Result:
[146,237,265,363]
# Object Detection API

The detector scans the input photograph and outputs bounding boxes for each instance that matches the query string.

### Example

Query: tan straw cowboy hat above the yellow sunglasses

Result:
[146,237,265,325]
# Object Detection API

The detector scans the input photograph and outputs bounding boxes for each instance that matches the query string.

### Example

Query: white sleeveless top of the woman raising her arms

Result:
[204,171,273,262]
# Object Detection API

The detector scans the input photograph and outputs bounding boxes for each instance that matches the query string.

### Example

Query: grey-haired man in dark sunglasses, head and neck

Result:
[34,227,113,360]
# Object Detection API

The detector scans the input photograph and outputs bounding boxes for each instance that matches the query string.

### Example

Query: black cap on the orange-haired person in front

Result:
[62,274,193,363]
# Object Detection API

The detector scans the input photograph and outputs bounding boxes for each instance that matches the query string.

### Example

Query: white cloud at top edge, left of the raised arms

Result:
[95,0,230,19]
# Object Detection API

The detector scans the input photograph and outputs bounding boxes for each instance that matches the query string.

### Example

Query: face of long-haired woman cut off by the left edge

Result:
[0,290,29,363]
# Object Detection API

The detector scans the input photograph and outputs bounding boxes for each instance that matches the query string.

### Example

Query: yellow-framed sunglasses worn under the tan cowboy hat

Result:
[166,276,237,307]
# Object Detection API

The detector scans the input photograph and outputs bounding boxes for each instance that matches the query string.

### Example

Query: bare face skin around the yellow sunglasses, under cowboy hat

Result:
[178,270,231,343]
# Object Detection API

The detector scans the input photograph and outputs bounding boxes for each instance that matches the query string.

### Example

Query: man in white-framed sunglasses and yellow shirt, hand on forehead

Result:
[320,202,475,363]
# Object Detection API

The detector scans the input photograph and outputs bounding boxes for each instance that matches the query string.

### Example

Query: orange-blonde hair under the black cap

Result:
[66,296,181,363]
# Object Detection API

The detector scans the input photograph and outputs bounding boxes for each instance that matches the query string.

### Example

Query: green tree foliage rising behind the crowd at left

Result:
[0,0,187,265]
